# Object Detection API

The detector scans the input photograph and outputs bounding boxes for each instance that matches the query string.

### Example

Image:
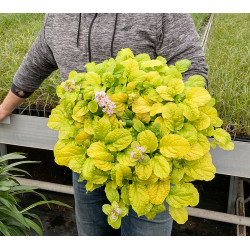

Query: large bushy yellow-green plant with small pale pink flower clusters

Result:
[48,48,234,228]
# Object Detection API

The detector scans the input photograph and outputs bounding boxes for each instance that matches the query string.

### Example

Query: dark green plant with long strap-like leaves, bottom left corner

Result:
[0,153,70,236]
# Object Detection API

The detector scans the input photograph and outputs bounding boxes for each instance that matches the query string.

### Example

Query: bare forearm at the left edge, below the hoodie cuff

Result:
[0,90,25,120]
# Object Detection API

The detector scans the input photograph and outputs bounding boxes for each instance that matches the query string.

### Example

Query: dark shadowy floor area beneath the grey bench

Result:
[7,145,250,236]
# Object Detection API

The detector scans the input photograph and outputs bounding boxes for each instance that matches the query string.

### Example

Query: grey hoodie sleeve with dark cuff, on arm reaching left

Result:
[11,13,58,97]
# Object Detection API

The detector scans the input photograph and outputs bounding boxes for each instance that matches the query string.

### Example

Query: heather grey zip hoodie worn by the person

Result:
[11,13,208,97]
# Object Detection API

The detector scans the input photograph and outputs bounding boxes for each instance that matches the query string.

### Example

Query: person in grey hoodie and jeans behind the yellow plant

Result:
[0,13,208,236]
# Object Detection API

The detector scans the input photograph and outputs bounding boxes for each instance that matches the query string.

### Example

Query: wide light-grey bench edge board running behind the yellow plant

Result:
[0,115,250,178]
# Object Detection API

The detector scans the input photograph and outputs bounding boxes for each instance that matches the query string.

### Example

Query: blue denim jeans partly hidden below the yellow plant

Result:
[73,172,173,236]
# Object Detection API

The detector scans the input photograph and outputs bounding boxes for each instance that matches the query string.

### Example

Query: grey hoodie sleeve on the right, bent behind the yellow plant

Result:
[156,13,208,87]
